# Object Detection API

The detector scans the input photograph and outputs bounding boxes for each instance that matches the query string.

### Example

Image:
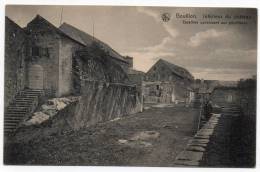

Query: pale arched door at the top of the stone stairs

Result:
[28,65,43,89]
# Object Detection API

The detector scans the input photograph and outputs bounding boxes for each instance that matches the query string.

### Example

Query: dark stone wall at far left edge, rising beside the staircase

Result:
[4,17,26,107]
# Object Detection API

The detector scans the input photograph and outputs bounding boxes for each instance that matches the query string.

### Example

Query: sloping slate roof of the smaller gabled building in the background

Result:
[155,59,194,80]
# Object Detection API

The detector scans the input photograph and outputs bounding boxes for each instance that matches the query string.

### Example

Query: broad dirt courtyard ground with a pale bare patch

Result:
[5,104,199,166]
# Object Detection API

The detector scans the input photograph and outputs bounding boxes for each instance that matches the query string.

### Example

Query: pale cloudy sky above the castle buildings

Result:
[6,5,257,81]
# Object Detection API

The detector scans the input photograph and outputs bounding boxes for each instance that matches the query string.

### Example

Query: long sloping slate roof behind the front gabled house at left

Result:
[59,23,126,62]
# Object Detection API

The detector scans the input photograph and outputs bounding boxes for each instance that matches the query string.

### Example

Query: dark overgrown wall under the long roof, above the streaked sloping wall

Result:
[72,44,129,94]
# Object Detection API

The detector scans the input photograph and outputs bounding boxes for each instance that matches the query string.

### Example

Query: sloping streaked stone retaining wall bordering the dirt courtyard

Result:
[67,81,142,129]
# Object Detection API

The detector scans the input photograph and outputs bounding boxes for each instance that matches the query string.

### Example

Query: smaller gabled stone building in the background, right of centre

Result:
[143,59,194,103]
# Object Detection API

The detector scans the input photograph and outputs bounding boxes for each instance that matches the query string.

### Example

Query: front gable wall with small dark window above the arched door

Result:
[26,20,60,96]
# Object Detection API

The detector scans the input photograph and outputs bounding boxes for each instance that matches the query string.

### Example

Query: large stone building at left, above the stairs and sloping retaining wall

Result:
[5,15,132,104]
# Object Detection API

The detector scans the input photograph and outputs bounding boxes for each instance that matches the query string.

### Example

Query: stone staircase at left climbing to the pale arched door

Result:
[4,89,44,134]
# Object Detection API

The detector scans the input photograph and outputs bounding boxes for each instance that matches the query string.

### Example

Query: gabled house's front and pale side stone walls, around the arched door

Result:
[26,16,83,97]
